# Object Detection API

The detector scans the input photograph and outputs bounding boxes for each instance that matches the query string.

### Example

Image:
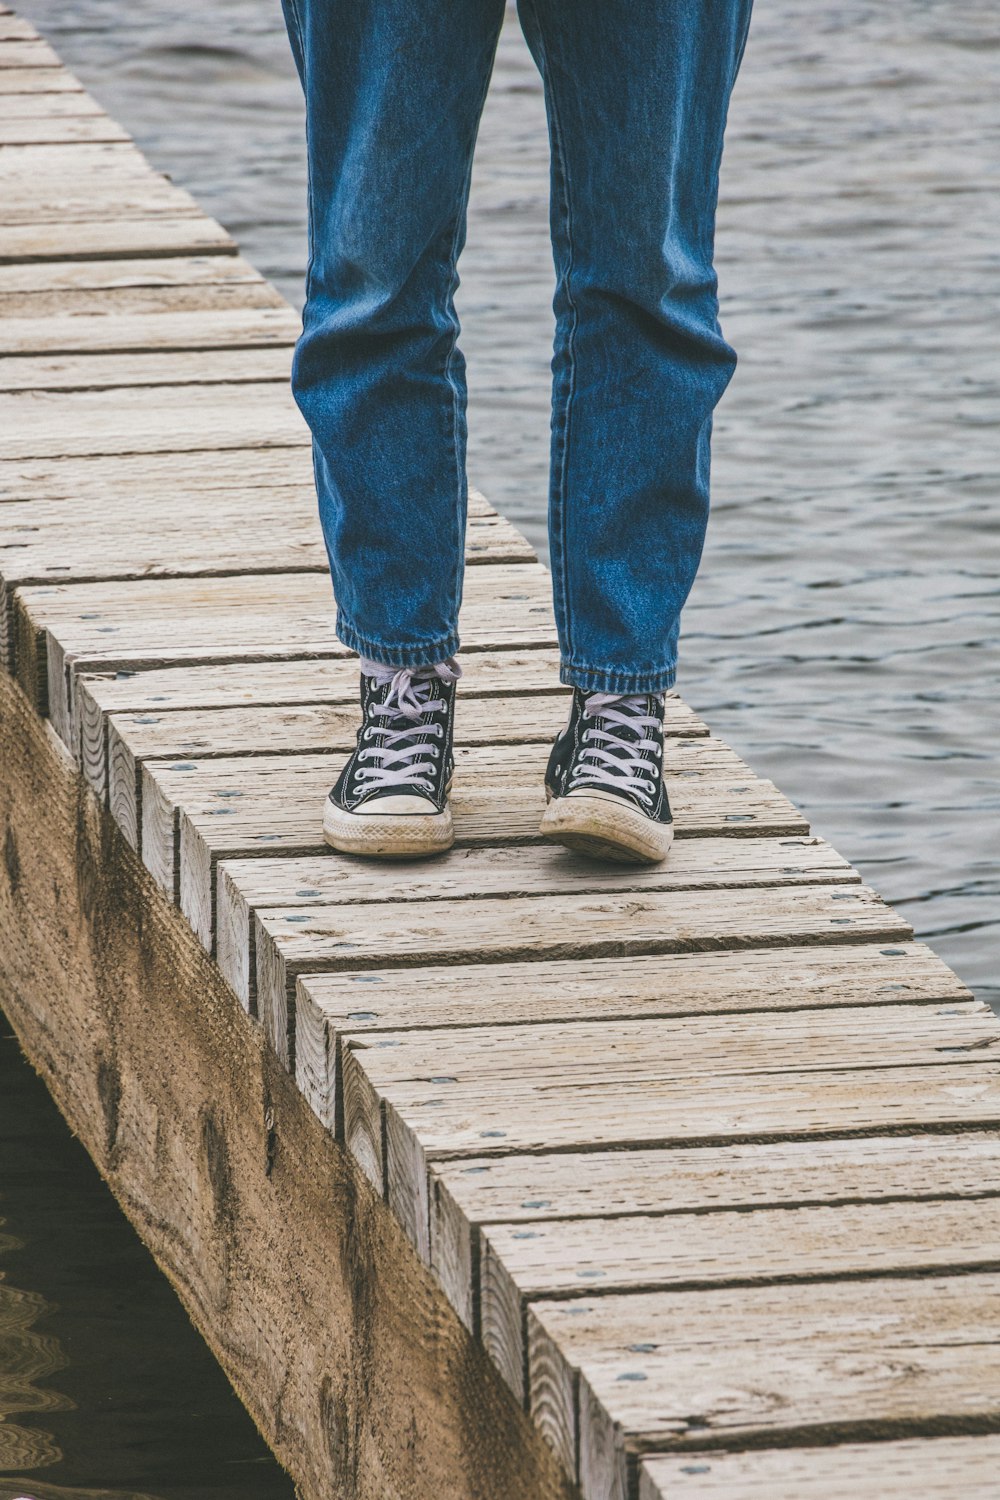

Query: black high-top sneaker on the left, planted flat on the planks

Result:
[322,660,462,858]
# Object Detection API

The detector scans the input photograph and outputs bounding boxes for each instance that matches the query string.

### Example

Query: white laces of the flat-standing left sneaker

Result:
[357,659,462,795]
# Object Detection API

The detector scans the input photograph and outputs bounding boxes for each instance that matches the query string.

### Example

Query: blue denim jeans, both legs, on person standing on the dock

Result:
[283,0,751,693]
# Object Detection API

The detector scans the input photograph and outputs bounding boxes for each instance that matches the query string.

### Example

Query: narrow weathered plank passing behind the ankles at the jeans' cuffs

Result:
[70,645,566,795]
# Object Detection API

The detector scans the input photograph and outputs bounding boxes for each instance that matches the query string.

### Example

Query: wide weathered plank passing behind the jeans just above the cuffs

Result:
[12,564,555,743]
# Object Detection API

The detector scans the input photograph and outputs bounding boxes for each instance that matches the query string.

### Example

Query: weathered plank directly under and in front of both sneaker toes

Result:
[218,840,861,1028]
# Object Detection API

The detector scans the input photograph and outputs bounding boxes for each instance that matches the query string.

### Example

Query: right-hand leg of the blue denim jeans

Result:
[519,0,751,693]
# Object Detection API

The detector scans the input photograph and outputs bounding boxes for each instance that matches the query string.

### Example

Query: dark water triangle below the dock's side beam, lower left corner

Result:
[0,1016,294,1500]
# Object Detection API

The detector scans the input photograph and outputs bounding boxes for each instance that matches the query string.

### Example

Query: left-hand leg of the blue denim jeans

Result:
[283,0,504,668]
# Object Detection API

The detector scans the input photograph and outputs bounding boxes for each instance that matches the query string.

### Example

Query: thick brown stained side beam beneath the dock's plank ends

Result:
[0,672,573,1500]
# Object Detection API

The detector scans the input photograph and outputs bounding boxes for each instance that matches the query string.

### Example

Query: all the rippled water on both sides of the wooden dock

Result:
[0,0,1000,1500]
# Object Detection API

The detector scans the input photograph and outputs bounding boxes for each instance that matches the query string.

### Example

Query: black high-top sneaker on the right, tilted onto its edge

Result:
[541,687,673,864]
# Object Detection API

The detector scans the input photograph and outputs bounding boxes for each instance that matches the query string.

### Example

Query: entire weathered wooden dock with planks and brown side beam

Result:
[0,14,1000,1500]
